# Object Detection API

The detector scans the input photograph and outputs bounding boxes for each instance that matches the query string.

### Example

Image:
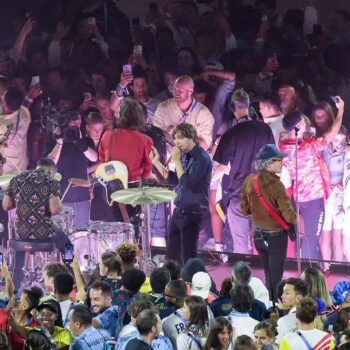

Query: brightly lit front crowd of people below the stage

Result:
[0,252,350,350]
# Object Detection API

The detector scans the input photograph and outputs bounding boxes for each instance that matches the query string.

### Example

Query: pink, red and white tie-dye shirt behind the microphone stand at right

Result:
[278,132,327,203]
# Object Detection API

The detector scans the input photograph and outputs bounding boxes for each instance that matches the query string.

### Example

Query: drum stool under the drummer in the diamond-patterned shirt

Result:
[8,239,56,286]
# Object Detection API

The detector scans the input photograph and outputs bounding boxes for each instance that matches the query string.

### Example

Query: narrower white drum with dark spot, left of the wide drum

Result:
[69,231,98,272]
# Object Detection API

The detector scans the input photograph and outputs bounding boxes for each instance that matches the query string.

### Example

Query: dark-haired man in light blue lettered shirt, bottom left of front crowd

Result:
[69,304,110,350]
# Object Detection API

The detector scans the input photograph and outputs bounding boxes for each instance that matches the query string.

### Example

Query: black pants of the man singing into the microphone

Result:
[167,208,204,263]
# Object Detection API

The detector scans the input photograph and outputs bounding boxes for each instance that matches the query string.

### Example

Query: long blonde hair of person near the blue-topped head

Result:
[301,267,333,307]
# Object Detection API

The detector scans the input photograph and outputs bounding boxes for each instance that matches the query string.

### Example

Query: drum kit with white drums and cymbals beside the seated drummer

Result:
[0,170,176,275]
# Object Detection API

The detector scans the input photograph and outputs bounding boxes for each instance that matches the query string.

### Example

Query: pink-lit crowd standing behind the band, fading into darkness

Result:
[0,0,350,270]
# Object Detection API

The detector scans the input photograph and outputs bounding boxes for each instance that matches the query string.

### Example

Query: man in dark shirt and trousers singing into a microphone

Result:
[150,123,212,263]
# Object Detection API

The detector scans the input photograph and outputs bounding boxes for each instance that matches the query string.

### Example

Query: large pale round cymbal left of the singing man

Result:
[111,187,176,205]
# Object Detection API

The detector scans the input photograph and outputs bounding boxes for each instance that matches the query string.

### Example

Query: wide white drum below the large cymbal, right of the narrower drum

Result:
[88,221,135,260]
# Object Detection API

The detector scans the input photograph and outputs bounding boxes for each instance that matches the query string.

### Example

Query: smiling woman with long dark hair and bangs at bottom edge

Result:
[203,317,233,350]
